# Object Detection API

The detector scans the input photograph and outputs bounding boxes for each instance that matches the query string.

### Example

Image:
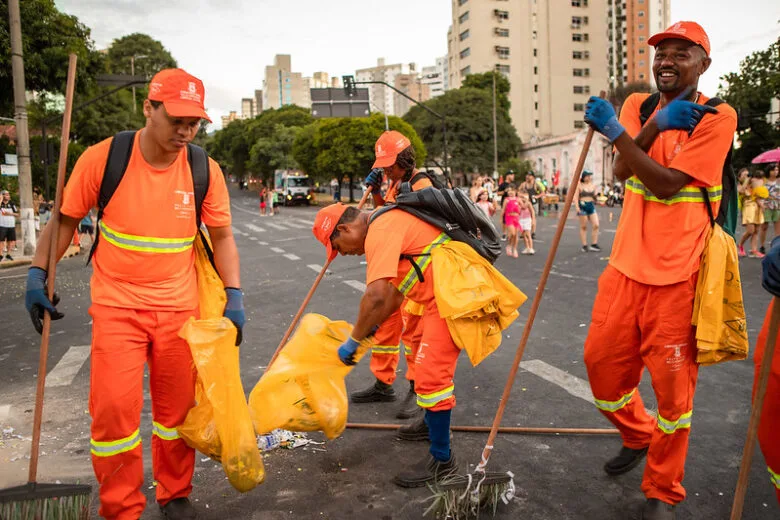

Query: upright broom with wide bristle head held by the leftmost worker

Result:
[0,54,92,520]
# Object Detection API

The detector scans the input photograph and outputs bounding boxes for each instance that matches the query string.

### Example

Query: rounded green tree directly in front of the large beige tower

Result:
[404,87,520,173]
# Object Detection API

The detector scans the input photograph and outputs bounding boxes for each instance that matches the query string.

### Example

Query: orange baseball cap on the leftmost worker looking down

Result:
[149,69,211,123]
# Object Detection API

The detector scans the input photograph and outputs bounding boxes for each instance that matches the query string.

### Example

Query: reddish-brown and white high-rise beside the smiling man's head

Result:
[607,0,671,87]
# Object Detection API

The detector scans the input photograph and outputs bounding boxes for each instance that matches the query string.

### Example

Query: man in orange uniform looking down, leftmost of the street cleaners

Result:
[25,69,245,520]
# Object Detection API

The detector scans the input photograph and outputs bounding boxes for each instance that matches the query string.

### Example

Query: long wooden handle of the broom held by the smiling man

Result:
[475,90,606,472]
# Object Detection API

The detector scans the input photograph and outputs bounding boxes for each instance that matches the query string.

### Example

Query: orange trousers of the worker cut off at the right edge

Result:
[753,301,780,504]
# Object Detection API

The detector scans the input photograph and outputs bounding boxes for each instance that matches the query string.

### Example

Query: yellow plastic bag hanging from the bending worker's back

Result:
[431,240,527,366]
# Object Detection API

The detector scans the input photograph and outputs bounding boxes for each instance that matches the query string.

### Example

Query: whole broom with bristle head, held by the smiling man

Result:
[426,98,606,519]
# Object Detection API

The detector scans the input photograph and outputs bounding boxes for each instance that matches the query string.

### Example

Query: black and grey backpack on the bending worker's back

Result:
[368,182,501,270]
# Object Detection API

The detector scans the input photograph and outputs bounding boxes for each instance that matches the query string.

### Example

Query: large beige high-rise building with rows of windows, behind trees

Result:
[447,0,609,141]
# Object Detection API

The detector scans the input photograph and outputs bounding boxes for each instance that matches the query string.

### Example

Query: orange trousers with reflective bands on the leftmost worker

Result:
[89,304,197,520]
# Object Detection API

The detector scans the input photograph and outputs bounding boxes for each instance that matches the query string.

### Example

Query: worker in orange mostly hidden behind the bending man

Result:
[350,130,433,426]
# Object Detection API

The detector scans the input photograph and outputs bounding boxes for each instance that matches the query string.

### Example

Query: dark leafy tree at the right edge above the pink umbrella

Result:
[718,39,780,168]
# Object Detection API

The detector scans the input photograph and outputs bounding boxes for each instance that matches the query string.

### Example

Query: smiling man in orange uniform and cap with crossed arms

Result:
[585,22,737,520]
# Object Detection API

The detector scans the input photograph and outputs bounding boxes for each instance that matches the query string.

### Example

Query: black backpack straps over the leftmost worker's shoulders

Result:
[87,130,216,264]
